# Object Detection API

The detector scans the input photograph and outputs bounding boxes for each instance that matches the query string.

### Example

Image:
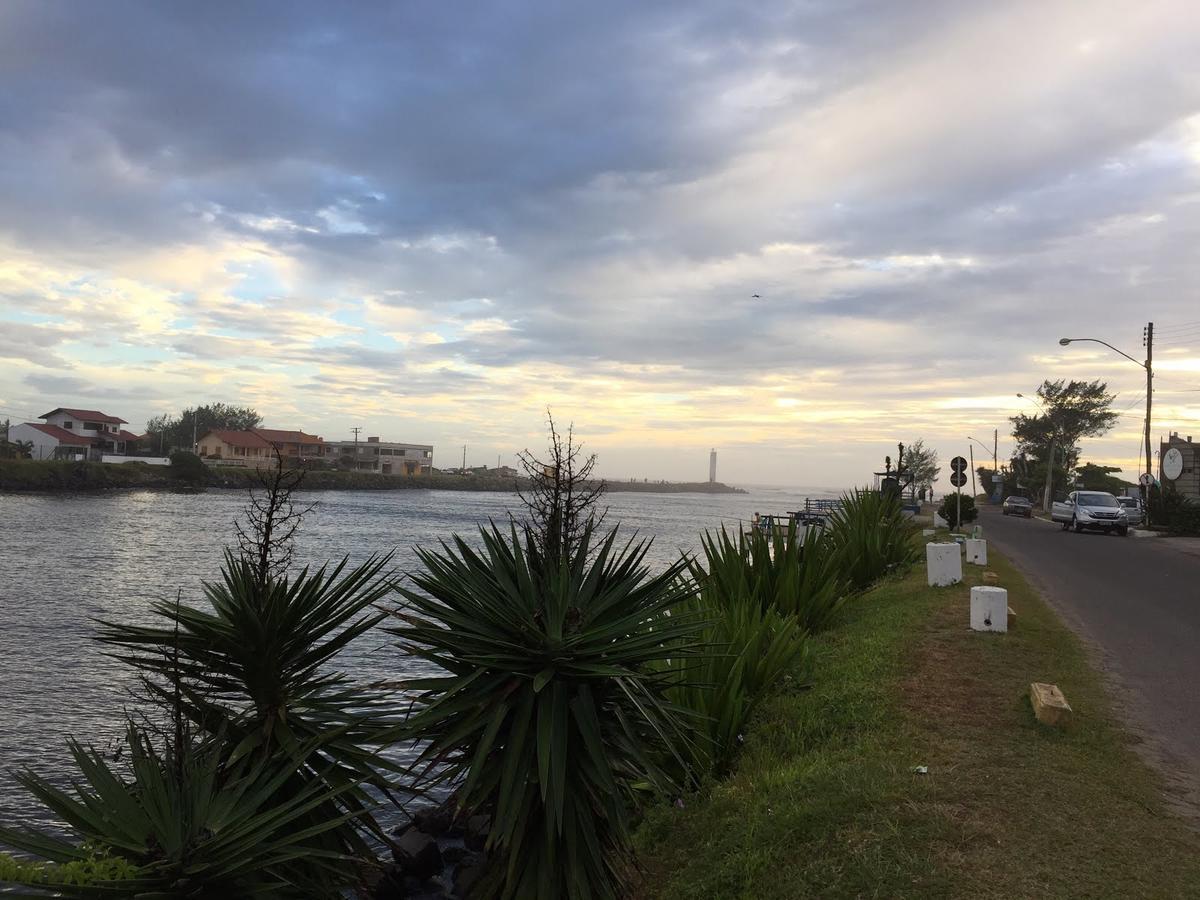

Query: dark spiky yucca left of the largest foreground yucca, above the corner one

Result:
[98,552,398,865]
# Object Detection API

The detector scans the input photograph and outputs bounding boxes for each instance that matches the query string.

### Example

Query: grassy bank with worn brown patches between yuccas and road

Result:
[637,547,1200,900]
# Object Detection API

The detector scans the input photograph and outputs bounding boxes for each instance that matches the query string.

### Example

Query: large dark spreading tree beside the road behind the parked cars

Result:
[1010,378,1118,510]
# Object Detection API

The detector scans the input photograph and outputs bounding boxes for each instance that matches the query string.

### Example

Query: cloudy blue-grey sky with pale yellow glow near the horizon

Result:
[0,0,1200,488]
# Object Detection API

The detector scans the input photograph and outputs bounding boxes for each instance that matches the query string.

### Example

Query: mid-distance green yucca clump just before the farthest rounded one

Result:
[689,522,847,631]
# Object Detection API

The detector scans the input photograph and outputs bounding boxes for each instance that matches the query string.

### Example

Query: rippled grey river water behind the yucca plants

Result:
[0,491,823,824]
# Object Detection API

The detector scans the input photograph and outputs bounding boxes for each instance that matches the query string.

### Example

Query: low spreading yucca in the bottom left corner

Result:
[0,724,356,900]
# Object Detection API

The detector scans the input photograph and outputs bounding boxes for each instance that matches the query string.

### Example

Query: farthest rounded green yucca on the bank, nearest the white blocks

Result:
[824,490,918,590]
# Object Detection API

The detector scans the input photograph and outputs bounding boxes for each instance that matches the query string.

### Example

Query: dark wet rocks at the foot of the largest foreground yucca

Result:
[374,797,492,900]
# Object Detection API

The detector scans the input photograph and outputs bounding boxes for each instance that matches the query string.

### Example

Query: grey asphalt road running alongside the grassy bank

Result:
[979,506,1200,817]
